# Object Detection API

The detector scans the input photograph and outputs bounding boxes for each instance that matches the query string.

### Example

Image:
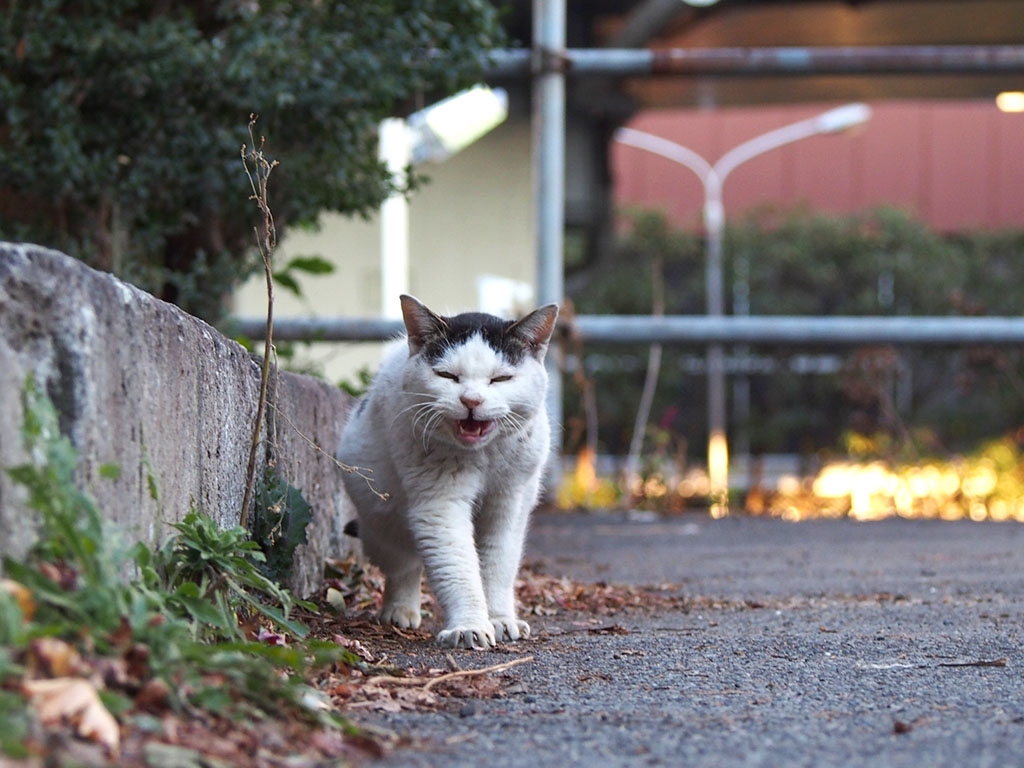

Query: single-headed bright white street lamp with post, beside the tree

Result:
[377,85,509,317]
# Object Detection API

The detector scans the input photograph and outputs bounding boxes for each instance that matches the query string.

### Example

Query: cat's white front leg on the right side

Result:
[476,476,540,641]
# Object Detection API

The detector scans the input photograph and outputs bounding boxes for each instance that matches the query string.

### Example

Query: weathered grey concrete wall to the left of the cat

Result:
[0,243,353,595]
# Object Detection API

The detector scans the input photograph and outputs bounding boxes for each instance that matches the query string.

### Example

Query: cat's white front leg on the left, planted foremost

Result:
[410,501,495,648]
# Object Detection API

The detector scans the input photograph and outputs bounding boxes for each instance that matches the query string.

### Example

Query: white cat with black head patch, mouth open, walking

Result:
[339,295,558,649]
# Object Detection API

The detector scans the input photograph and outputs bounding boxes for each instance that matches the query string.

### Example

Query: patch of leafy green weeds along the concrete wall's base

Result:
[0,379,366,757]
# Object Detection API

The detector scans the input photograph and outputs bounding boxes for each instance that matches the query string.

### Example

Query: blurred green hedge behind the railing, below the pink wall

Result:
[566,209,1024,457]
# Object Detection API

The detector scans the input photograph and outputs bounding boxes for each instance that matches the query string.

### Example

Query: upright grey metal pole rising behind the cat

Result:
[532,0,565,482]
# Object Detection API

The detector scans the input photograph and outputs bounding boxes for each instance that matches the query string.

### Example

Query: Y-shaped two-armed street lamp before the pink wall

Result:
[615,103,871,517]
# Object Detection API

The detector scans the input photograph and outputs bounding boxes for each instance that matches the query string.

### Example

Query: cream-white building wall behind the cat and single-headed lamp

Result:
[233,120,536,382]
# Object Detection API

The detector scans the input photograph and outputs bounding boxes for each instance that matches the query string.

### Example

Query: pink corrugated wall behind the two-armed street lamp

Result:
[611,100,1024,231]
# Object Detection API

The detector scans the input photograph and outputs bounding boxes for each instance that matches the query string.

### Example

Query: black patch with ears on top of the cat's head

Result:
[401,296,558,366]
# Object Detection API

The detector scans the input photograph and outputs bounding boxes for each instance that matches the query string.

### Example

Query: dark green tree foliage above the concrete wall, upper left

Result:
[0,0,502,317]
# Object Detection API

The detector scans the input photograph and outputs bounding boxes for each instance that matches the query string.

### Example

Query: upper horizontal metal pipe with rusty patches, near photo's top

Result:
[485,45,1024,78]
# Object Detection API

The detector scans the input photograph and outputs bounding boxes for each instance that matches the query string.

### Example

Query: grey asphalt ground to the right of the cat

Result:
[357,515,1024,768]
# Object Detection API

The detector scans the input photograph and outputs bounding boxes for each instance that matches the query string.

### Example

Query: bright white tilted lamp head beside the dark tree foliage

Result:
[407,85,509,165]
